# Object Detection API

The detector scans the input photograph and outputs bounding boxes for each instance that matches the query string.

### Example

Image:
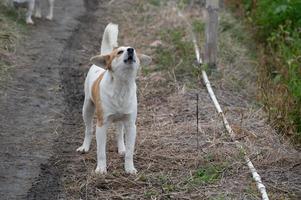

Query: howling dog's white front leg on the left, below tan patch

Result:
[95,123,108,174]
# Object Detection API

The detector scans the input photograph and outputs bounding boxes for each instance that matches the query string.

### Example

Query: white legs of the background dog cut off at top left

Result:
[12,0,54,24]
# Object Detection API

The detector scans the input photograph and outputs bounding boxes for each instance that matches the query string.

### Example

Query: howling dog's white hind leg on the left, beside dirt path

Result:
[76,97,95,153]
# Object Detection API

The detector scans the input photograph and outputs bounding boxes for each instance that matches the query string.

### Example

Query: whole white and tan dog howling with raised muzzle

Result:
[77,23,151,174]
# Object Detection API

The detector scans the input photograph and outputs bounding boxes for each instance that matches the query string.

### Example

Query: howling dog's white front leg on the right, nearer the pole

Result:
[124,121,137,174]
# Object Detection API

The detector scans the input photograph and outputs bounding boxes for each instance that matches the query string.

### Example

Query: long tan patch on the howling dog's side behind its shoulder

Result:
[92,72,105,127]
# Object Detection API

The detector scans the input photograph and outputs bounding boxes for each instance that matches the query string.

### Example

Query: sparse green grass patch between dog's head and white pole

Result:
[143,27,200,87]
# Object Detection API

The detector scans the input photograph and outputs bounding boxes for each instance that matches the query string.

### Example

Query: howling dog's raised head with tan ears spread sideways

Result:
[91,46,152,77]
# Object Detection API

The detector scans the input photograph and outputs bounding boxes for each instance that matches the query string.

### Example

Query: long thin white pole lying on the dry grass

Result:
[178,12,269,200]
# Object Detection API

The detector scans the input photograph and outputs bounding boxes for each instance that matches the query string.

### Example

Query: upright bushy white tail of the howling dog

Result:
[100,23,118,55]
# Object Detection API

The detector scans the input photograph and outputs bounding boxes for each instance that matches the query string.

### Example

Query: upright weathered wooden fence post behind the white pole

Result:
[204,0,219,67]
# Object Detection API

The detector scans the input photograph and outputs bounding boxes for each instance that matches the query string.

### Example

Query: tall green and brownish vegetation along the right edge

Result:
[225,0,301,144]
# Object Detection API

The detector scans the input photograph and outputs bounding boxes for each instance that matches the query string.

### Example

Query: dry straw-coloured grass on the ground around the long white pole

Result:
[63,0,301,199]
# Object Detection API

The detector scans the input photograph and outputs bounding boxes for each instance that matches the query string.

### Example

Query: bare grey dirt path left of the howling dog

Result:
[0,0,97,199]
